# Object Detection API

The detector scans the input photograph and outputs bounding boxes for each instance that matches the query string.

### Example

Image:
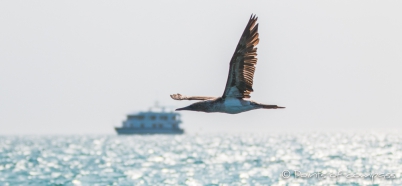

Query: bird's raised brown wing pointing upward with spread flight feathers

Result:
[222,15,259,98]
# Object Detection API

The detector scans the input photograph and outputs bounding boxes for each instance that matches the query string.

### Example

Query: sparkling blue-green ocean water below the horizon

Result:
[0,133,402,186]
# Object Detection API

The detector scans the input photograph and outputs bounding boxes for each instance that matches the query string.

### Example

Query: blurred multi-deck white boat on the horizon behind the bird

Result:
[115,103,184,135]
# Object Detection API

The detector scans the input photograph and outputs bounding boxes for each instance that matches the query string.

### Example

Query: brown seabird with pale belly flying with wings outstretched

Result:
[170,14,285,114]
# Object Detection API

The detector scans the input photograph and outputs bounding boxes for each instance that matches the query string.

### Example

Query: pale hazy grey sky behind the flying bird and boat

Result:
[0,0,402,134]
